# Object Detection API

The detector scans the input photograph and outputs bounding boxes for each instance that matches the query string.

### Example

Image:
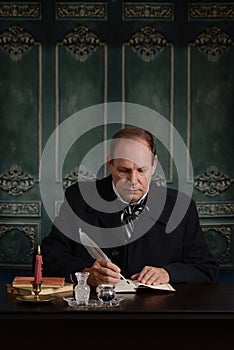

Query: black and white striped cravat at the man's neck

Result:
[120,196,149,239]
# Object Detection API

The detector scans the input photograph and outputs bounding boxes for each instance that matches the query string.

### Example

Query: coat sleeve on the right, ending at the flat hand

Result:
[164,200,219,283]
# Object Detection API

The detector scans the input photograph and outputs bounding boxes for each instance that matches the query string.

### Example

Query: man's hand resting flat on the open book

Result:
[131,266,170,286]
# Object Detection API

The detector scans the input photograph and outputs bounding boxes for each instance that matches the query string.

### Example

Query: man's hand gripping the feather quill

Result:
[82,259,120,287]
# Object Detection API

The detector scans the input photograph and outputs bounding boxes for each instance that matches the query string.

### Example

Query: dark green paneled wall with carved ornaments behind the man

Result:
[0,0,234,268]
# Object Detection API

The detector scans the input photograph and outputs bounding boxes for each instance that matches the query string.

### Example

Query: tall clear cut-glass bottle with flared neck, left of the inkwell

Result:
[74,272,90,306]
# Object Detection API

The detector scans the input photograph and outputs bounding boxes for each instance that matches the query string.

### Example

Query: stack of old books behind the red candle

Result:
[6,276,73,295]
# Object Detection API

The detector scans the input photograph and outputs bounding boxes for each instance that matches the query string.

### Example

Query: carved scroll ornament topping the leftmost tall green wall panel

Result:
[0,25,38,61]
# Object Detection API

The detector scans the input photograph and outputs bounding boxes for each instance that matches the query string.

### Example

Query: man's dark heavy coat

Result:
[41,176,218,283]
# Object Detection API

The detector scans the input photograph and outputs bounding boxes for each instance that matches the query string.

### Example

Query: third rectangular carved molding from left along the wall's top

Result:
[122,2,174,20]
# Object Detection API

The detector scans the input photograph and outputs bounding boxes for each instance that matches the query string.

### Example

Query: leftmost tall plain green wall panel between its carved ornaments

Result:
[0,48,41,176]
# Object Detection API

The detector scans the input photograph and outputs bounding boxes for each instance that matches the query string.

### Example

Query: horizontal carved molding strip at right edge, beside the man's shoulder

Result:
[196,202,234,218]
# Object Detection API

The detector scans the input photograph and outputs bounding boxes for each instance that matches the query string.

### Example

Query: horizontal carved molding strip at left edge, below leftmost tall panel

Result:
[0,201,41,217]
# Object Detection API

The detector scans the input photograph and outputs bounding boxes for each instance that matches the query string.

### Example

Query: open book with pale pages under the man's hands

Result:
[115,279,176,293]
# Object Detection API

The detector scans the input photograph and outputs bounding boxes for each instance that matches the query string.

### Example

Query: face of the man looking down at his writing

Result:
[108,138,157,202]
